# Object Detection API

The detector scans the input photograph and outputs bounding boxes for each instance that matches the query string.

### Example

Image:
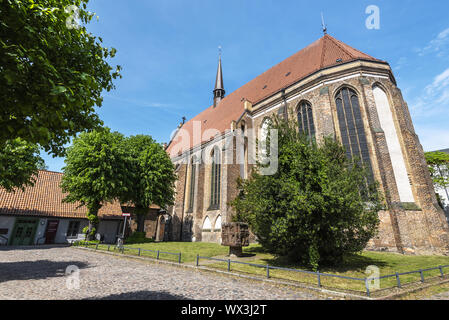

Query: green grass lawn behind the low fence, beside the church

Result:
[75,242,449,292]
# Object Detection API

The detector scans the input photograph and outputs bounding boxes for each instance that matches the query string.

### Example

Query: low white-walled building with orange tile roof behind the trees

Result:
[0,171,123,245]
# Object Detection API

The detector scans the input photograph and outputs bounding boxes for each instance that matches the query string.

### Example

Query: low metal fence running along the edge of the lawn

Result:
[73,241,449,297]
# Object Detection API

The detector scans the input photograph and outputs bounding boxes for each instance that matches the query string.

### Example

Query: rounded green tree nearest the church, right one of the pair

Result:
[123,135,176,232]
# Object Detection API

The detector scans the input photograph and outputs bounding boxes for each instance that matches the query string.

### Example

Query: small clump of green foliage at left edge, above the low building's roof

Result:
[0,138,45,192]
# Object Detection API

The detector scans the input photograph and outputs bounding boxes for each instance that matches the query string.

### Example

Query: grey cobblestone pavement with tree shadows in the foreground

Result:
[0,247,319,300]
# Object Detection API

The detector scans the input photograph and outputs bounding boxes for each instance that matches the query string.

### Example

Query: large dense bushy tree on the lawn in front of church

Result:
[231,116,382,269]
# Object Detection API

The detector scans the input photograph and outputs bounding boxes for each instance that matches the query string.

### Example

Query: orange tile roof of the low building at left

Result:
[0,171,122,219]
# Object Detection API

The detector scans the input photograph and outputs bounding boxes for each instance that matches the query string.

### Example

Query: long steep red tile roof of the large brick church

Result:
[167,35,383,157]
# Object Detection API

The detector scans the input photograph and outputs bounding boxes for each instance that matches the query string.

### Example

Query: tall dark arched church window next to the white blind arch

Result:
[335,88,373,176]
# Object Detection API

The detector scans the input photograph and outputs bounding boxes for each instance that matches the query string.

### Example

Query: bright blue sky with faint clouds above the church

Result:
[43,0,449,171]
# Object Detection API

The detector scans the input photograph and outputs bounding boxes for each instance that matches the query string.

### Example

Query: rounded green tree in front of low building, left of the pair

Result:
[61,128,130,239]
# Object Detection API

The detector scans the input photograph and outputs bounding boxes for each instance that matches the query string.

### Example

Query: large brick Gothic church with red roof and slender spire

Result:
[167,34,449,254]
